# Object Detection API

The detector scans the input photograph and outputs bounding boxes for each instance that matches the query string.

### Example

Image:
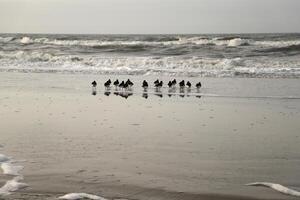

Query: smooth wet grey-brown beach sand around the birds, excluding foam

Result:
[0,73,300,200]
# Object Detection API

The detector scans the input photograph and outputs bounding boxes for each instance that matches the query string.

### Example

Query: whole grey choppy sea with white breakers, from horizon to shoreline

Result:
[0,33,300,78]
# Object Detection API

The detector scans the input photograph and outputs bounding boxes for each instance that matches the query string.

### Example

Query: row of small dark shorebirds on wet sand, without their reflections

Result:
[92,79,202,89]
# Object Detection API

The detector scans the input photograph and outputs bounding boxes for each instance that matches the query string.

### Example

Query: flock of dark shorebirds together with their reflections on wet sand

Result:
[92,79,202,99]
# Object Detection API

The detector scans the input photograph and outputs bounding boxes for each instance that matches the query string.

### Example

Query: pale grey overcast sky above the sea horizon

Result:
[0,0,300,34]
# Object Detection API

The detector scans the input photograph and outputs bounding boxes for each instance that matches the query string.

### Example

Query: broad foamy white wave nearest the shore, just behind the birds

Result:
[0,51,300,78]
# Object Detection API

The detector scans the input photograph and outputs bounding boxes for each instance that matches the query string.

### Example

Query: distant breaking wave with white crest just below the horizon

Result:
[0,35,300,48]
